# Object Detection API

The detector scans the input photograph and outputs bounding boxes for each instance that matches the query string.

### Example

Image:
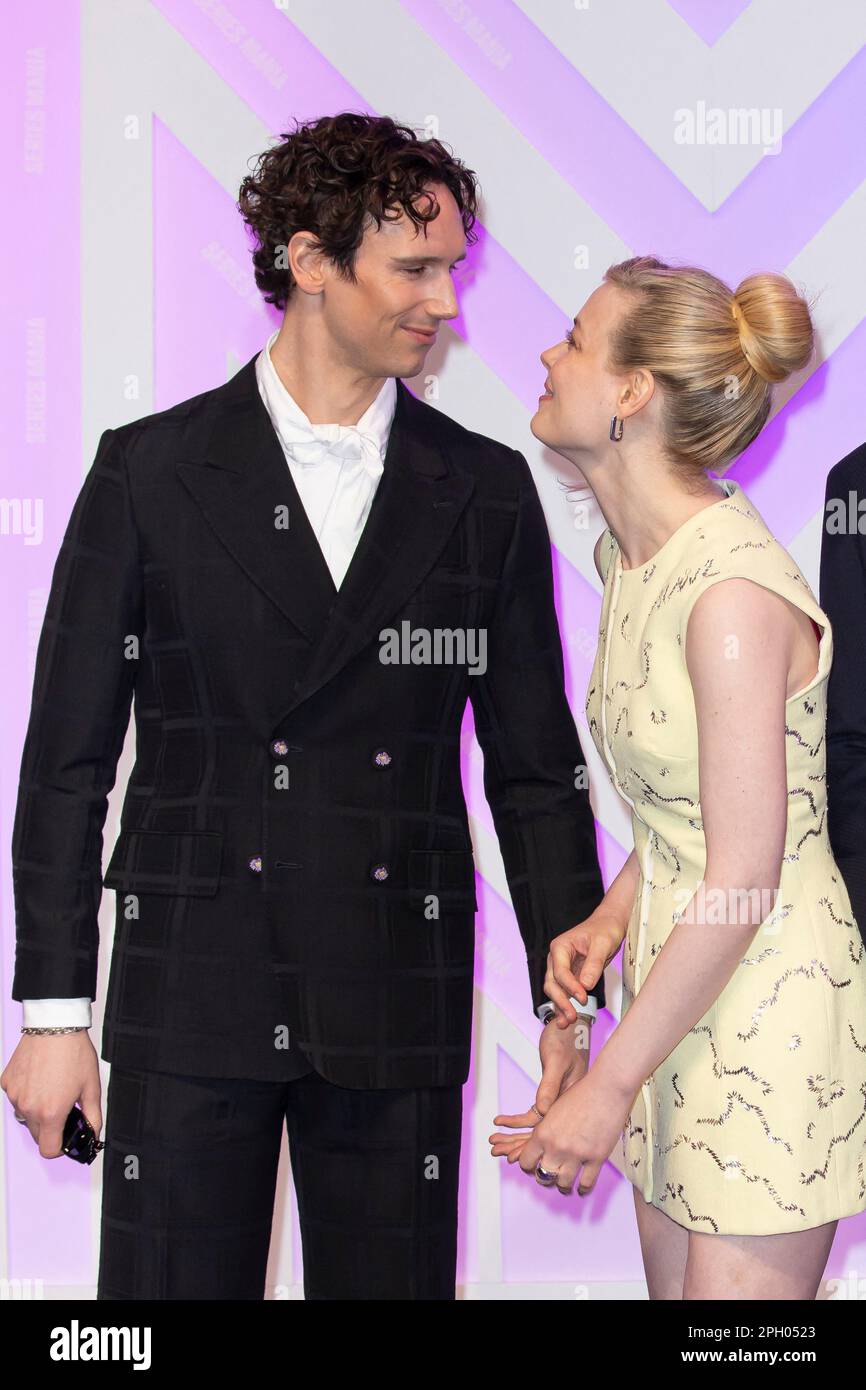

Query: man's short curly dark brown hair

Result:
[238,111,478,309]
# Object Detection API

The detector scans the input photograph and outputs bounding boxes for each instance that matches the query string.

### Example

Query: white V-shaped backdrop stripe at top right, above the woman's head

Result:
[516,0,866,210]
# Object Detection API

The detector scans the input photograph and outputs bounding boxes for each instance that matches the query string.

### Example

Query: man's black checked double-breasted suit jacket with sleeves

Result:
[13,357,603,1088]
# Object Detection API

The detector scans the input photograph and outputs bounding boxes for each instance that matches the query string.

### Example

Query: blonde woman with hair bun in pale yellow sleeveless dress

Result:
[492,257,866,1300]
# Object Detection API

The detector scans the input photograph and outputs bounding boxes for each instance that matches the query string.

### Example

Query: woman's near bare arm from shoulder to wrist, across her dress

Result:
[595,578,796,1094]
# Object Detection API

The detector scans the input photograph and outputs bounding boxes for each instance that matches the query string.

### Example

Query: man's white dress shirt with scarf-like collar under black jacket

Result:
[22,331,398,1029]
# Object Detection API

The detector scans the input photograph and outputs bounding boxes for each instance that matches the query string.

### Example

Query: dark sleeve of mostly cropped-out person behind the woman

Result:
[819,461,866,940]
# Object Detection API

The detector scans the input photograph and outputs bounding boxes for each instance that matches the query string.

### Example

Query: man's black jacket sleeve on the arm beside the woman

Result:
[468,450,605,1009]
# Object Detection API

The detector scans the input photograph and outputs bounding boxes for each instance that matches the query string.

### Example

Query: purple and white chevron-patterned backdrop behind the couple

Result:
[0,0,866,1300]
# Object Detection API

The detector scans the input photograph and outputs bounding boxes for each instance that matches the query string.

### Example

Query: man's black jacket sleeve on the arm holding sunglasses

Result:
[11,430,143,999]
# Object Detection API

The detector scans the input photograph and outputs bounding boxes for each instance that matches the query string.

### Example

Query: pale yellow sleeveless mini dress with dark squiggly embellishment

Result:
[585,480,866,1236]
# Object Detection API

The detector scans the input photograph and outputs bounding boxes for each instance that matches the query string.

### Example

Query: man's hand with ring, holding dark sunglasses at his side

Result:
[0,1024,101,1158]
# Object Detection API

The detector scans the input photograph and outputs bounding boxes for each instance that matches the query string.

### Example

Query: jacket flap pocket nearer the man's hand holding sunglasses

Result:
[103,830,222,898]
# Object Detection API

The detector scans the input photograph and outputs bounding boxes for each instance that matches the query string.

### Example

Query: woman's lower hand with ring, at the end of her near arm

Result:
[492,1061,637,1197]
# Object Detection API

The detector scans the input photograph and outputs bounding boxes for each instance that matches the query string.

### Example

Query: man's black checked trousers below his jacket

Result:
[96,1066,463,1300]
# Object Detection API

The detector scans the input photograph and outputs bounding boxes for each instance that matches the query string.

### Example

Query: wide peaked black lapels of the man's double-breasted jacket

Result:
[178,357,474,717]
